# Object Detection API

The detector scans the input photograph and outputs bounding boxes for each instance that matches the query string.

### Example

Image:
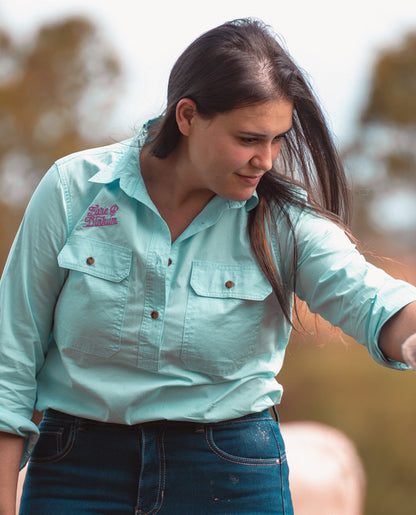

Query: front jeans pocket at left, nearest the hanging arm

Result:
[31,420,76,463]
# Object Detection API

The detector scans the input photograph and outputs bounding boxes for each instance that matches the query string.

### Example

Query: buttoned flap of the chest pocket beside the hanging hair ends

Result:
[191,261,272,300]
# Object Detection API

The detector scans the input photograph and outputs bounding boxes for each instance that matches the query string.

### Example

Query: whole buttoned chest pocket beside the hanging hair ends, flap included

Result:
[181,261,272,376]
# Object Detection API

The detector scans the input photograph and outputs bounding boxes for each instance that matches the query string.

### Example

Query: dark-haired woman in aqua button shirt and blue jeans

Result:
[0,20,416,515]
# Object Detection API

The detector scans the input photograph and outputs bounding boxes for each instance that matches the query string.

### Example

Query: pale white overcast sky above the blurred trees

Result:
[0,0,416,144]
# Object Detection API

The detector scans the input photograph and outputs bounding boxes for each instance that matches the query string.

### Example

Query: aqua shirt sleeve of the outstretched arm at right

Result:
[295,214,416,369]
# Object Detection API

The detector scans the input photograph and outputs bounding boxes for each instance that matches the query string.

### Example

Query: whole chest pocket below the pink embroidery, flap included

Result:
[54,236,132,357]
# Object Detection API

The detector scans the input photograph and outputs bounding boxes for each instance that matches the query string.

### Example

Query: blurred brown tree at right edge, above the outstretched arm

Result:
[344,32,416,249]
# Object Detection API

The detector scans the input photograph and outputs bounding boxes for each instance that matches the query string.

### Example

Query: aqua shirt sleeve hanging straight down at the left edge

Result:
[0,167,68,464]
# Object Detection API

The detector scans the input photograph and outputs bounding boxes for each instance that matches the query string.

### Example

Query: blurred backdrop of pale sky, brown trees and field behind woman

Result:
[0,0,416,515]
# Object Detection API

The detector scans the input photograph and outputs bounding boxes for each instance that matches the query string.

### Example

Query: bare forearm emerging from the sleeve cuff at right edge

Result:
[378,302,416,363]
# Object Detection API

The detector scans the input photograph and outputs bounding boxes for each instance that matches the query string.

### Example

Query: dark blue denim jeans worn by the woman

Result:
[20,410,293,515]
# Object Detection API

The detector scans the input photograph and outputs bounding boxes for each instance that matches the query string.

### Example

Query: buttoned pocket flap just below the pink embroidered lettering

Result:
[58,236,132,282]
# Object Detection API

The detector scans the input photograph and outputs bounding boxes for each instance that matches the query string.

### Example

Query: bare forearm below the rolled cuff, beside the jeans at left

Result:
[0,431,24,515]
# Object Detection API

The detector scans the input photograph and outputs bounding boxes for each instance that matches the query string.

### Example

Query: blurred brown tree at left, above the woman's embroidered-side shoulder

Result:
[0,18,120,209]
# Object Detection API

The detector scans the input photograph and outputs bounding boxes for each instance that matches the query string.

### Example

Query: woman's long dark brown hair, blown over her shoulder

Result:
[146,19,350,321]
